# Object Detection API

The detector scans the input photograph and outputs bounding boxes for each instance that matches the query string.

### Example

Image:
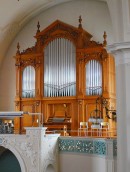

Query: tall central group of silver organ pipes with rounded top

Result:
[44,38,76,97]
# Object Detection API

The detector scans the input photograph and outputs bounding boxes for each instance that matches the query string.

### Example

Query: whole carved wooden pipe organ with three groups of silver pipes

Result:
[15,17,115,132]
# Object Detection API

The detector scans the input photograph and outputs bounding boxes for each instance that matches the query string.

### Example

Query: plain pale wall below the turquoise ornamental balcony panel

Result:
[59,153,116,172]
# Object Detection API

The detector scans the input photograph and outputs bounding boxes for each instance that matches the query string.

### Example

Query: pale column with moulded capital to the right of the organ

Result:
[109,42,130,172]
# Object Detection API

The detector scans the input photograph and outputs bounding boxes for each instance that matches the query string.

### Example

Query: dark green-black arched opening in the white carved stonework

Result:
[0,146,21,172]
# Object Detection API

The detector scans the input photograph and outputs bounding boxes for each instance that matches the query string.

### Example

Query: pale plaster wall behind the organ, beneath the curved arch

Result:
[0,0,113,111]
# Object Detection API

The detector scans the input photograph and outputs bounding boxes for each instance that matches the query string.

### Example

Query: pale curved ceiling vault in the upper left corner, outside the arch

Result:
[0,0,106,64]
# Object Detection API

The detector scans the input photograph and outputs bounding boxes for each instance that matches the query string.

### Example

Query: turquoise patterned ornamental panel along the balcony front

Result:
[59,137,117,156]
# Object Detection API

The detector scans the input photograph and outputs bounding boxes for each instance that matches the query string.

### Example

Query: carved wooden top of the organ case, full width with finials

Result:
[16,19,104,55]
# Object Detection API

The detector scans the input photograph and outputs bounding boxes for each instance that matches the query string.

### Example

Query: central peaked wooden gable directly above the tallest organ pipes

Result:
[35,20,92,48]
